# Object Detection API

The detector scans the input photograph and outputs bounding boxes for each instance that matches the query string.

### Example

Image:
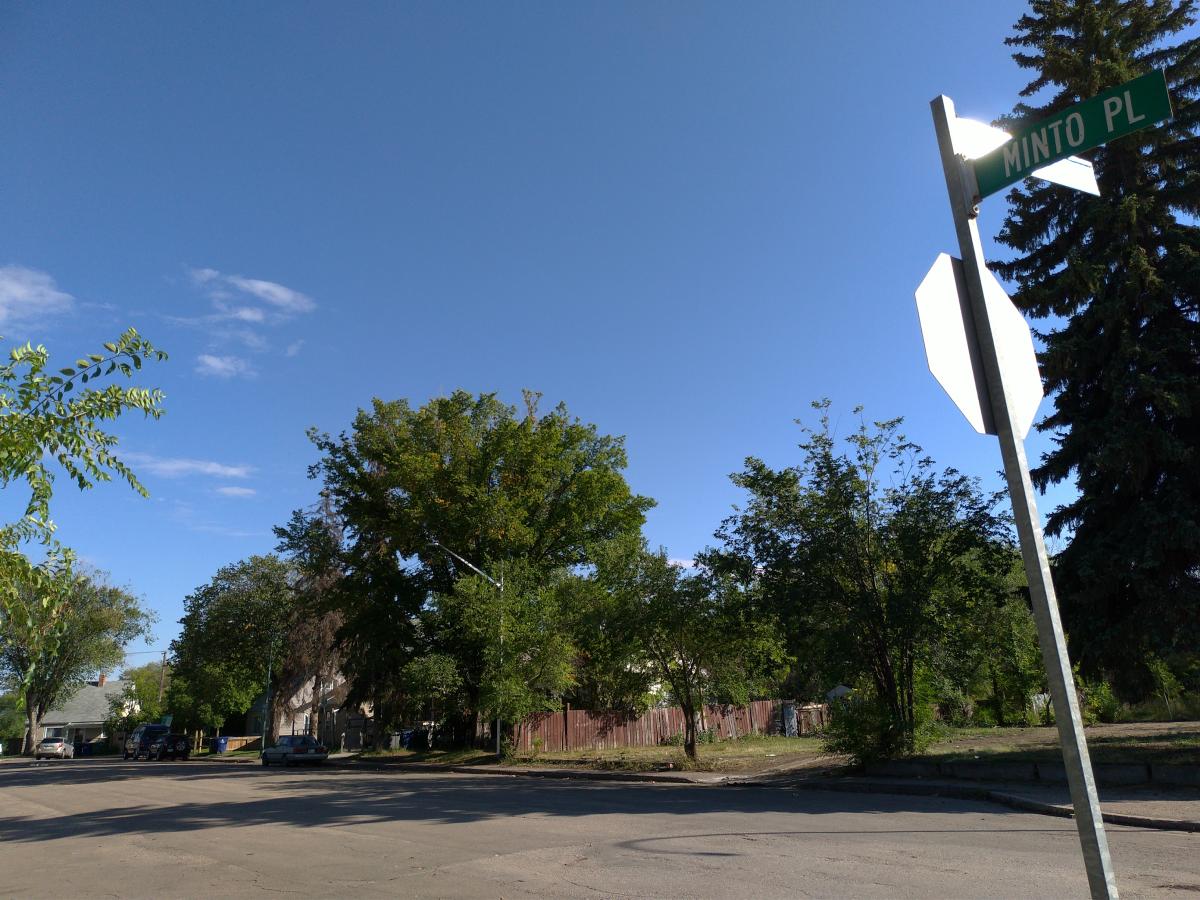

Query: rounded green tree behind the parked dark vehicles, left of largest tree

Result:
[167,556,294,728]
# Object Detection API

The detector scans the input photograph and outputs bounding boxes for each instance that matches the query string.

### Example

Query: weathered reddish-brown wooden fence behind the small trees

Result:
[514,700,829,751]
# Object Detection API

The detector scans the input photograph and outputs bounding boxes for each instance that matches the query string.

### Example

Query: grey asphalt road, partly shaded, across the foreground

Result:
[0,760,1200,898]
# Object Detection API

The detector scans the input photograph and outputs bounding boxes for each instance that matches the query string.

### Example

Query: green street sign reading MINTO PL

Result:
[972,71,1171,198]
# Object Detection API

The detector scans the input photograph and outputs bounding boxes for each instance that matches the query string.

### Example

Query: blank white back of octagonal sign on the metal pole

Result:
[917,253,1042,440]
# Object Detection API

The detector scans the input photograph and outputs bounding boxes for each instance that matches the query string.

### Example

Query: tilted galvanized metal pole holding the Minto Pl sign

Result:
[930,96,1117,899]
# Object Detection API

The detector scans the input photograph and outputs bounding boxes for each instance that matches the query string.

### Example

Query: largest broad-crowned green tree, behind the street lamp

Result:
[304,391,652,737]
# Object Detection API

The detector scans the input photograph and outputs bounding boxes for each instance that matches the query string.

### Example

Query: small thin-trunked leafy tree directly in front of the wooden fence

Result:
[596,542,787,760]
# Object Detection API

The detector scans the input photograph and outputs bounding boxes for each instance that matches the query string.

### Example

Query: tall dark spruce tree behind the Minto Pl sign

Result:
[996,0,1200,696]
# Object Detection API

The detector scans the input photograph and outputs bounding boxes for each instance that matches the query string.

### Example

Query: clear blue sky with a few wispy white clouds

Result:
[0,0,1123,661]
